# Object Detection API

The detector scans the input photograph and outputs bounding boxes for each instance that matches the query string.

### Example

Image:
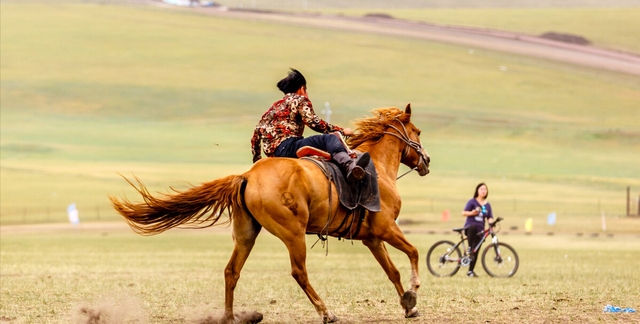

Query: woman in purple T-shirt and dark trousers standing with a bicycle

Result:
[462,183,493,277]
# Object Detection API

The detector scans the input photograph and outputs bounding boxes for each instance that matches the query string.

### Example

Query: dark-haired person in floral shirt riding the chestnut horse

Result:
[251,69,370,181]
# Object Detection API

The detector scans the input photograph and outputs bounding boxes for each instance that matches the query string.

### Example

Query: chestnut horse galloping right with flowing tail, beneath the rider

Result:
[109,104,430,323]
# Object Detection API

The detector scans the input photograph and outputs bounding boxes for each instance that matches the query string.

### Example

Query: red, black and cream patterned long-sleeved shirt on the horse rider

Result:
[251,93,343,163]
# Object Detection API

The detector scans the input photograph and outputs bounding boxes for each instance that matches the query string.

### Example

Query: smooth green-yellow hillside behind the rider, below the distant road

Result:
[0,2,640,233]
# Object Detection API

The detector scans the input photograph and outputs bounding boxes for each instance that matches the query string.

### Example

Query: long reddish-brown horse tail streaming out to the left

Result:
[109,175,246,236]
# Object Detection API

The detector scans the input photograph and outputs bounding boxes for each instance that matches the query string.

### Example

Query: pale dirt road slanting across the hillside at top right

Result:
[141,0,640,75]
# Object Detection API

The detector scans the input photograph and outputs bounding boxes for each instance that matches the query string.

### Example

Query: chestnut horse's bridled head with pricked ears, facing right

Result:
[390,104,431,177]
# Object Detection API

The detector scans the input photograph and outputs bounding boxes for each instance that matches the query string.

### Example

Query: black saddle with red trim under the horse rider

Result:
[296,146,380,212]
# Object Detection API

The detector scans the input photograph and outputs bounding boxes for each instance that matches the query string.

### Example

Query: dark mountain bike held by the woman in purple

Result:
[427,217,520,278]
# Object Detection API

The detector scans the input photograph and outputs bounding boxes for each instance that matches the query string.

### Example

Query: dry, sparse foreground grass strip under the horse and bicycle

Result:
[0,229,640,324]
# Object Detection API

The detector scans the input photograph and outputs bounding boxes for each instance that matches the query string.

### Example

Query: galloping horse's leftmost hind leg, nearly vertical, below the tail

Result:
[224,212,262,323]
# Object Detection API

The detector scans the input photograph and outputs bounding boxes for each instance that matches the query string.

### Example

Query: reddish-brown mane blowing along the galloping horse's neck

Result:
[347,107,411,148]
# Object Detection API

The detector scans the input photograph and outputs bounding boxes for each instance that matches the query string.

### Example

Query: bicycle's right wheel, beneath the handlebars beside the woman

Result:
[482,242,520,278]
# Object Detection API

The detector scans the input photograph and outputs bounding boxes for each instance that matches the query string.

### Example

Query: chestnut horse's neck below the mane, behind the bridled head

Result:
[357,136,402,183]
